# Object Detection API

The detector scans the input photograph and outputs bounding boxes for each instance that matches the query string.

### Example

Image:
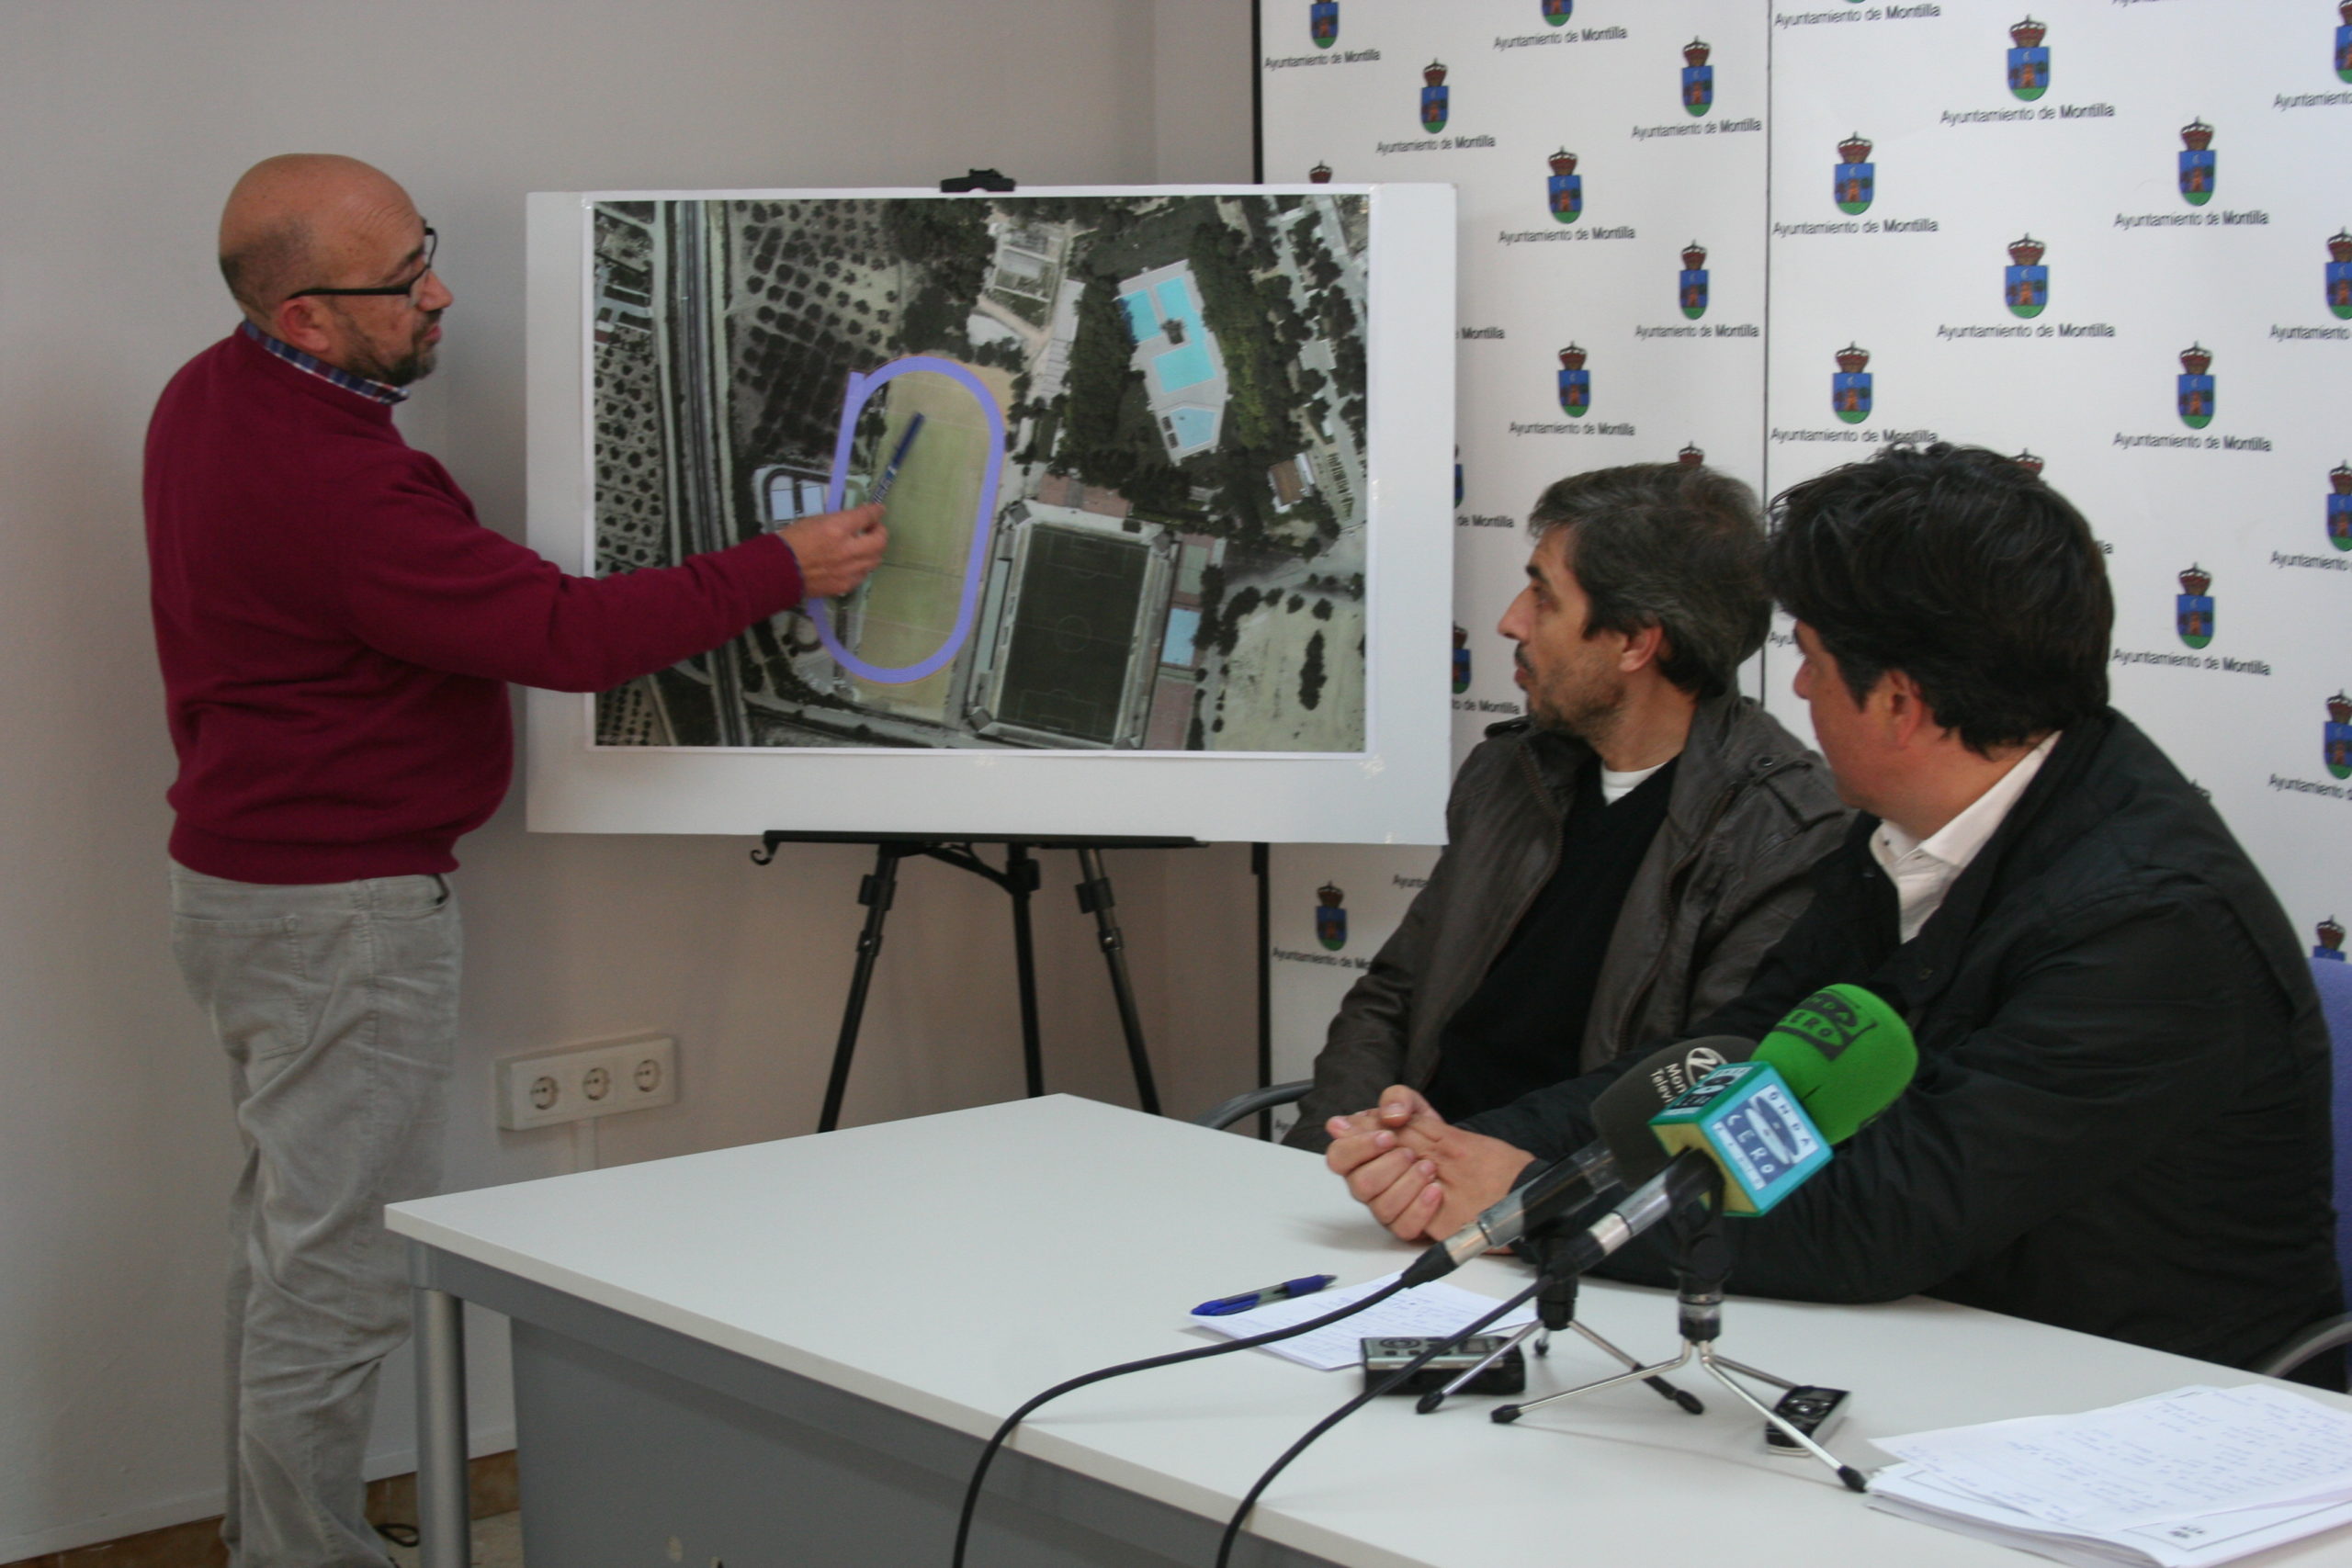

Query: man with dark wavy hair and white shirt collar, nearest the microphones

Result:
[1329,445,2340,1384]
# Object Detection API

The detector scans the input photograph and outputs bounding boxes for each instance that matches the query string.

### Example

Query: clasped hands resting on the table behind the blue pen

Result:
[1324,1084,1533,1241]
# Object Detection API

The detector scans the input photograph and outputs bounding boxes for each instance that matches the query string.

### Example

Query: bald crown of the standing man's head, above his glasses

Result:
[221,152,416,327]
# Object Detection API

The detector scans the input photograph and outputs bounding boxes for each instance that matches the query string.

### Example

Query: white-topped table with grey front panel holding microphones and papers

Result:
[388,1096,2352,1568]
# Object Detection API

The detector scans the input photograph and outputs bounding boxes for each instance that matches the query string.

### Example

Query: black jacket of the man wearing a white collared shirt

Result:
[1465,710,2338,1366]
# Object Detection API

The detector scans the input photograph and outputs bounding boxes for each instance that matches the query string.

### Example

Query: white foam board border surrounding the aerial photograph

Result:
[525,184,1456,844]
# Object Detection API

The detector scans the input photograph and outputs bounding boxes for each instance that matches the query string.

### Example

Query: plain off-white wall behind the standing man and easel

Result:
[0,0,1251,1563]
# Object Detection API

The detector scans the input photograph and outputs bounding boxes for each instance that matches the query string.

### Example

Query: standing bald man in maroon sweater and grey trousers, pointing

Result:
[146,155,885,1568]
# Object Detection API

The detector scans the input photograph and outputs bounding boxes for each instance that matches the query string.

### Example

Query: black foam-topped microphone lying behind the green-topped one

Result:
[1404,1034,1755,1288]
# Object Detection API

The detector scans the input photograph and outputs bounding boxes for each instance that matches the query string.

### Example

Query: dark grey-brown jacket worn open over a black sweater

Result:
[1284,696,1847,1149]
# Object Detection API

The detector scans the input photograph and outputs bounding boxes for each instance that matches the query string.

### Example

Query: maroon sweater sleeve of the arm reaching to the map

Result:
[339,449,799,691]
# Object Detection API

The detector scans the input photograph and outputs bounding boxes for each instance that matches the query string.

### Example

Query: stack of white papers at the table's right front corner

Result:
[1870,1384,2352,1568]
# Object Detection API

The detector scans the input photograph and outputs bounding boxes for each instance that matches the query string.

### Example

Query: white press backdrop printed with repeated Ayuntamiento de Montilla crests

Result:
[1259,0,2352,1133]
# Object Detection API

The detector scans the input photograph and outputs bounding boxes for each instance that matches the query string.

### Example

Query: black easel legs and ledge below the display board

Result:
[751,829,1202,1134]
